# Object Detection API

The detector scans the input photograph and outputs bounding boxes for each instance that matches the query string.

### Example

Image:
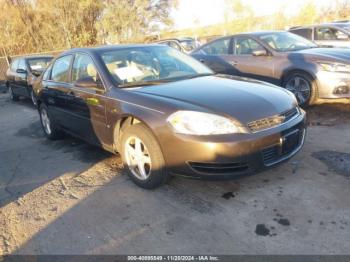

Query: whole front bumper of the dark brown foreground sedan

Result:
[161,108,306,179]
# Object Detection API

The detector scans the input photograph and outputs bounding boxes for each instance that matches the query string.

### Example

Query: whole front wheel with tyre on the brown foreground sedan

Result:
[121,124,169,189]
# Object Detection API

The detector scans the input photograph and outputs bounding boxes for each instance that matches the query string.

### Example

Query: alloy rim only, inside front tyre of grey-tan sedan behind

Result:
[286,76,311,105]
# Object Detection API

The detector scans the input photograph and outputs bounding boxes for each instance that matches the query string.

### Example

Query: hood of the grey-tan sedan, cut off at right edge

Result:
[295,48,350,63]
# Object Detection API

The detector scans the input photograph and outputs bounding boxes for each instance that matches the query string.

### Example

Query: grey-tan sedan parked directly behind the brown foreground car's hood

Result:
[192,31,350,105]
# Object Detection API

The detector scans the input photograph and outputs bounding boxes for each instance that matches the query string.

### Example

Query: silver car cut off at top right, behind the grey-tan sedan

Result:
[289,21,350,48]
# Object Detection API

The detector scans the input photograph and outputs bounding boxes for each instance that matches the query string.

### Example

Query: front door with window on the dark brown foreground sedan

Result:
[67,53,107,146]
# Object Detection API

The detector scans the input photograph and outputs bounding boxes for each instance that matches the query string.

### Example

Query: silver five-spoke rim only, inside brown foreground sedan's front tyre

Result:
[124,136,152,180]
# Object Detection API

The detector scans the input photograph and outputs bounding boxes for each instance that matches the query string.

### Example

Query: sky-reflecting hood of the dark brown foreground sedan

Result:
[133,76,296,123]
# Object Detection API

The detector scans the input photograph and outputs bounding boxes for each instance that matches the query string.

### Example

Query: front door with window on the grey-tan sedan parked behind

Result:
[230,36,278,83]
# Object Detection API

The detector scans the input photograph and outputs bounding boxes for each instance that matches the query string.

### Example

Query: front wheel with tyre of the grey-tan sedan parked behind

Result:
[283,72,316,106]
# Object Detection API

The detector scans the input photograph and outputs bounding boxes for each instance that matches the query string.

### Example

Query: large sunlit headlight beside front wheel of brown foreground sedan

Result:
[167,111,245,135]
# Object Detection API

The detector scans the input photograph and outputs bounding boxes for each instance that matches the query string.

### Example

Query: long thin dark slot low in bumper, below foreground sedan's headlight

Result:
[189,162,248,174]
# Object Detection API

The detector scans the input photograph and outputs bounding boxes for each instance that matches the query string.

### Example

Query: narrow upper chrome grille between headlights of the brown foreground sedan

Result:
[248,107,299,133]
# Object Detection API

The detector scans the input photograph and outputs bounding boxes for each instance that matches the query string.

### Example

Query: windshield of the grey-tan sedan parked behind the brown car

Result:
[258,32,317,52]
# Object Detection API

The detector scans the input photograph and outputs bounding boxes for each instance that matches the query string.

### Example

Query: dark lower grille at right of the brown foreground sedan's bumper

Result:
[262,123,305,166]
